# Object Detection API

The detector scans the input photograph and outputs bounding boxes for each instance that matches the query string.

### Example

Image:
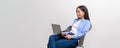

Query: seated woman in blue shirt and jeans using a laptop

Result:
[48,5,91,48]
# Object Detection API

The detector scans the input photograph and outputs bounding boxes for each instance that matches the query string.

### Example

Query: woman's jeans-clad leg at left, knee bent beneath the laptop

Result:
[47,34,64,48]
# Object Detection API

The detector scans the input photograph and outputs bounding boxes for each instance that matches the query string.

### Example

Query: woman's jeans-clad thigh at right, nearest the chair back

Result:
[56,39,78,48]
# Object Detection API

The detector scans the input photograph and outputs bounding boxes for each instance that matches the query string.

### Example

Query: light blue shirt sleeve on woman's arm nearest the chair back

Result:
[72,21,90,39]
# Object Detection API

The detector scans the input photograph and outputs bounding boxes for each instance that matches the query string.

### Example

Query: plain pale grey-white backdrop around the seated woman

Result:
[0,0,120,48]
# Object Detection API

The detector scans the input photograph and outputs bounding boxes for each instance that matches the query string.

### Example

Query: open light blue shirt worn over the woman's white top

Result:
[65,19,90,39]
